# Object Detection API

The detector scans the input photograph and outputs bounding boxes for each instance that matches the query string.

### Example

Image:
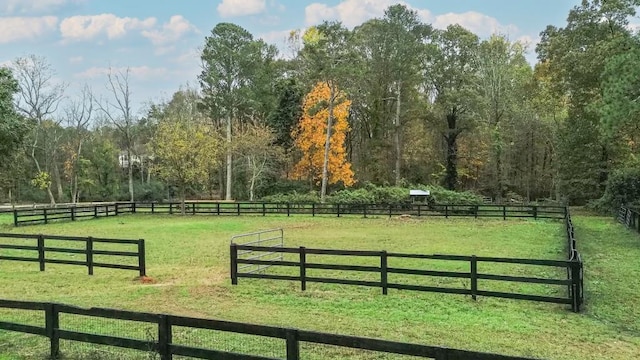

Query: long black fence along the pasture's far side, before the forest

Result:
[13,201,567,226]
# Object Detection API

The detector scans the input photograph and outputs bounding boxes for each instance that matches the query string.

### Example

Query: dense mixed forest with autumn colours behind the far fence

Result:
[0,0,640,207]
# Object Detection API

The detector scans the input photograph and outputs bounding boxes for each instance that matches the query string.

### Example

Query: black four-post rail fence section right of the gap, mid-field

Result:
[230,244,582,312]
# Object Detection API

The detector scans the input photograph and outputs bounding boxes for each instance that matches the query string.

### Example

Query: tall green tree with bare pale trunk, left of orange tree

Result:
[199,23,276,200]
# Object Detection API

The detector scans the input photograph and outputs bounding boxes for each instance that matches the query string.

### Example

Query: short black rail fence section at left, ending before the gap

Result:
[0,234,146,276]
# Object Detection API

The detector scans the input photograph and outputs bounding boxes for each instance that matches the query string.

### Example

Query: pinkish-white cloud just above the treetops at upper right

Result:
[432,11,518,36]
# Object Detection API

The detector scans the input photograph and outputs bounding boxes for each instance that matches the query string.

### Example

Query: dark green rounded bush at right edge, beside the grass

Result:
[589,168,640,213]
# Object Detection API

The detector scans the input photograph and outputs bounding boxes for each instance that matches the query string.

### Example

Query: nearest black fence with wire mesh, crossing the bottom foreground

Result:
[0,300,530,360]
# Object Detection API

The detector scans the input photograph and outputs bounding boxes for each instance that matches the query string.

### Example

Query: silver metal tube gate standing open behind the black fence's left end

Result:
[231,229,284,274]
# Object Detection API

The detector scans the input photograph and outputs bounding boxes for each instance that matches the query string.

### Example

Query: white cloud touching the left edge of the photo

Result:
[0,16,58,44]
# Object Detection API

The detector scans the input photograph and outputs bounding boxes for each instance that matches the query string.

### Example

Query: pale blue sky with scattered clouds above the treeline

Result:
[0,0,580,114]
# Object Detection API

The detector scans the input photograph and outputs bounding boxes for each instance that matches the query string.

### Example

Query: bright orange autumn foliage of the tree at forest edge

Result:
[291,82,355,186]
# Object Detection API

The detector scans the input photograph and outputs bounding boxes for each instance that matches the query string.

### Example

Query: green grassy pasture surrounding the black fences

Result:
[0,214,640,360]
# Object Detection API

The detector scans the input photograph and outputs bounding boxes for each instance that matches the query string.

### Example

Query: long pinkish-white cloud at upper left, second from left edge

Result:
[60,14,156,41]
